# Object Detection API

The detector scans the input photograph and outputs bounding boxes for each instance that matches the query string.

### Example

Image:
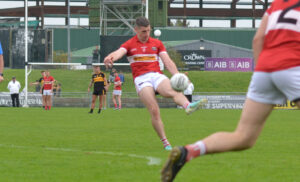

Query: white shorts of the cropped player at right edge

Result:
[247,66,300,104]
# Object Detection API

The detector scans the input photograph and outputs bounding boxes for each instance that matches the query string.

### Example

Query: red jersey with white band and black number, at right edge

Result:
[255,0,300,72]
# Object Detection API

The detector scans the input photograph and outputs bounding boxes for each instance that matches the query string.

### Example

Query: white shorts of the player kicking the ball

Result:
[134,72,168,93]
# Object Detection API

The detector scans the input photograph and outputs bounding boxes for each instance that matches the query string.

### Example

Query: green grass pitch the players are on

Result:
[0,108,300,182]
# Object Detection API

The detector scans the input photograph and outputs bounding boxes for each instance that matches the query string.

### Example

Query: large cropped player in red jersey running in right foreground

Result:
[161,0,300,182]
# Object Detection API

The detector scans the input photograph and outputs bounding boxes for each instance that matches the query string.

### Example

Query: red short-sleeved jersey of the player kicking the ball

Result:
[120,36,167,79]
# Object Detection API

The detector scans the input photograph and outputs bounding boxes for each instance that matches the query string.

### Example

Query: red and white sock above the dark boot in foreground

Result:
[185,141,206,162]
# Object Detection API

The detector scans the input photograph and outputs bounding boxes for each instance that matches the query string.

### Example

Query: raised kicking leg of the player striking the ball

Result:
[156,79,207,114]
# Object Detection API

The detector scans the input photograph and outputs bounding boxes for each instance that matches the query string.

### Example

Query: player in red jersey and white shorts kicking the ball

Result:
[104,17,204,150]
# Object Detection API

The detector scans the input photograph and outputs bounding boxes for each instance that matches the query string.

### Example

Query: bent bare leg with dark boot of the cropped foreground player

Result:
[161,99,273,182]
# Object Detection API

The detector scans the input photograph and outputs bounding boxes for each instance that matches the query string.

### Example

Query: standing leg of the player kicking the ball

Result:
[139,87,171,150]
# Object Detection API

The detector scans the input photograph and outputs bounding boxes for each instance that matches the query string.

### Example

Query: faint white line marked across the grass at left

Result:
[0,144,161,166]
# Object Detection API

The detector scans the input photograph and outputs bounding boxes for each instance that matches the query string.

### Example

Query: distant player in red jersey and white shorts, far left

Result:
[41,70,55,110]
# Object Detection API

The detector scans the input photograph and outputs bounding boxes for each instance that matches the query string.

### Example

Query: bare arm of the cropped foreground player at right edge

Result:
[252,15,268,65]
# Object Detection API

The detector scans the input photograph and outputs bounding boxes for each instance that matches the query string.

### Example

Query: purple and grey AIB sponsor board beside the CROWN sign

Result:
[205,58,253,72]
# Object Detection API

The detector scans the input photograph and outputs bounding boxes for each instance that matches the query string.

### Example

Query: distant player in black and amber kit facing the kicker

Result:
[88,66,107,114]
